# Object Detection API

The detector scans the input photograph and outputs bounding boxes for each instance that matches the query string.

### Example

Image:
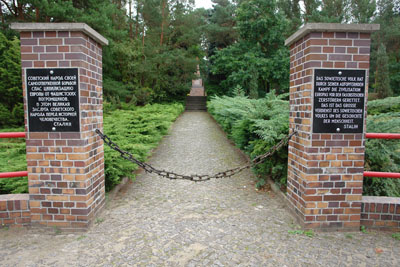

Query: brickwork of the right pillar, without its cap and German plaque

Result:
[287,28,371,229]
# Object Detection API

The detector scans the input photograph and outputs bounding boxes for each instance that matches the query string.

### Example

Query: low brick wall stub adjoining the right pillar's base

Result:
[361,196,400,231]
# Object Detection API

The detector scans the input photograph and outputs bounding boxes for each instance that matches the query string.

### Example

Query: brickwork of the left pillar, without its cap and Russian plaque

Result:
[21,31,105,228]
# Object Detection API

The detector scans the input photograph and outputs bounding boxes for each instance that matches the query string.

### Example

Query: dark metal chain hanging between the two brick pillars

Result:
[96,129,297,182]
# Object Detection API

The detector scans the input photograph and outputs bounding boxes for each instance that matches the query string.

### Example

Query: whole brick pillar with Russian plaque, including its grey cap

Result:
[11,23,108,229]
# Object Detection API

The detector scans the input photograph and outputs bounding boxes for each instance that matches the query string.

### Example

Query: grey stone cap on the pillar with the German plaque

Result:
[285,23,380,46]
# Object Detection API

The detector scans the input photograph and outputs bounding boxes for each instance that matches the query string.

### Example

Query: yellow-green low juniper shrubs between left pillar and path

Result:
[104,103,184,191]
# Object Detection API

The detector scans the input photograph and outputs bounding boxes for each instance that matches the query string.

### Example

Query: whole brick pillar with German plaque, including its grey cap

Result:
[285,23,379,230]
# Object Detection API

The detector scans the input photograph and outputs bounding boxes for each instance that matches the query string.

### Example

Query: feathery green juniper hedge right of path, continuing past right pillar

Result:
[208,92,400,197]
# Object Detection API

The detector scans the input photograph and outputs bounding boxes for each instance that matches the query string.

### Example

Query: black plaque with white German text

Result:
[313,69,366,133]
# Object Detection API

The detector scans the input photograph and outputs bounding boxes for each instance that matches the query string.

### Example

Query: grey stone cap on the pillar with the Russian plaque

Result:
[11,22,108,45]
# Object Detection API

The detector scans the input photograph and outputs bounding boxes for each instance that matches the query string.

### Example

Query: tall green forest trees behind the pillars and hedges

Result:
[0,0,400,127]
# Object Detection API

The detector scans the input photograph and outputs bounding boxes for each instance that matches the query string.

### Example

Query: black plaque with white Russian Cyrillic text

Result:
[26,68,79,132]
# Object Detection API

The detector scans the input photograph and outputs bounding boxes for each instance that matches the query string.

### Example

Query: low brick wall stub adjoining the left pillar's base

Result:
[0,194,31,228]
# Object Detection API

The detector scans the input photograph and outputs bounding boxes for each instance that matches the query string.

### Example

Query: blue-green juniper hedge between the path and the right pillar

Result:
[208,92,289,187]
